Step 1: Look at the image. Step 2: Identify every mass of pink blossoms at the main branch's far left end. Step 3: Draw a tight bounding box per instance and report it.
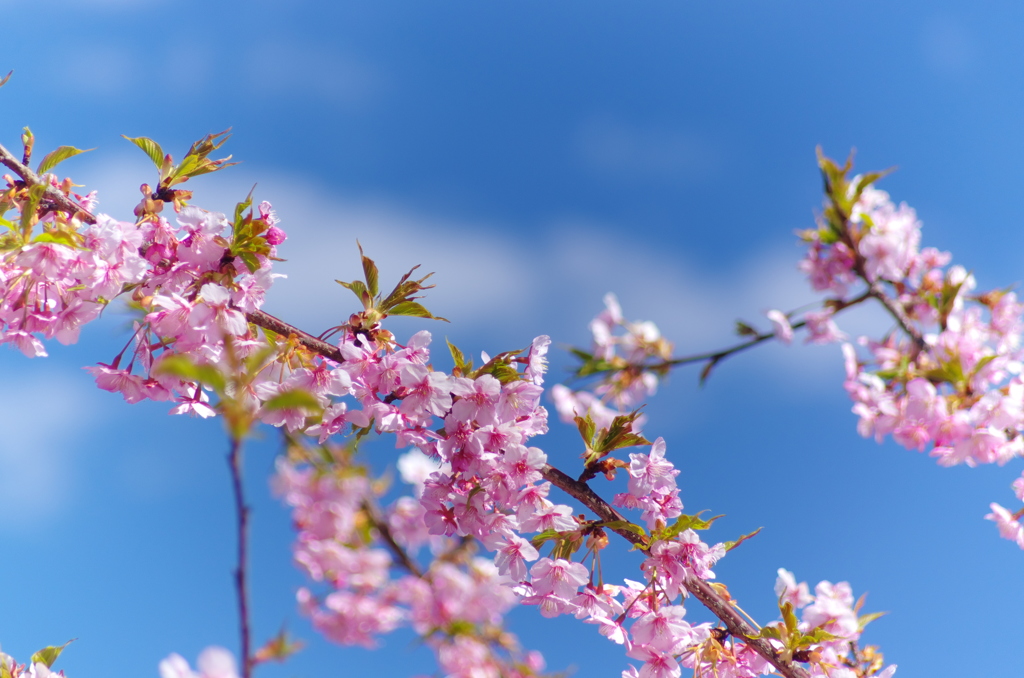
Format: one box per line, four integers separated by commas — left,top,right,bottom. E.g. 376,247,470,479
0,168,285,417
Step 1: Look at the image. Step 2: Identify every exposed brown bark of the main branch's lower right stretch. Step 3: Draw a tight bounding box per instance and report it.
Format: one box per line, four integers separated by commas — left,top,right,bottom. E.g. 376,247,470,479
542,465,810,678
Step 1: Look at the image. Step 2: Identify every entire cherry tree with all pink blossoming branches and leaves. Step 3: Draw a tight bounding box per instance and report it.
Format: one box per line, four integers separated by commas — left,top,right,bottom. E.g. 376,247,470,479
0,73,1024,678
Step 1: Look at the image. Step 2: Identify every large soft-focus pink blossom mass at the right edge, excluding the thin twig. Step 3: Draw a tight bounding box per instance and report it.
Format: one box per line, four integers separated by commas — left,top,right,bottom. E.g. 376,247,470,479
790,159,1024,548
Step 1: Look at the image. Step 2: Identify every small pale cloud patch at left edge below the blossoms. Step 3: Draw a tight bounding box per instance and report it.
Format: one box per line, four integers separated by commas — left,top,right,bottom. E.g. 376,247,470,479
0,372,92,525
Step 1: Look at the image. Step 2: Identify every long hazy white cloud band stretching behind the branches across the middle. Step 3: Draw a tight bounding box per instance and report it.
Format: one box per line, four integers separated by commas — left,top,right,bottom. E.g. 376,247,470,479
72,154,890,387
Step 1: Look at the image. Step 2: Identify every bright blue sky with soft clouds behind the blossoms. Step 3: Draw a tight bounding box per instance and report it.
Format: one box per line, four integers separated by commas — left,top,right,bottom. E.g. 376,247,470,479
0,0,1024,678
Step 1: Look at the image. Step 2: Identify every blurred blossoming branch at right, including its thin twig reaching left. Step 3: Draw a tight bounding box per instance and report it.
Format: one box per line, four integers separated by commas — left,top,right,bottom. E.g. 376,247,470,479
553,150,1024,549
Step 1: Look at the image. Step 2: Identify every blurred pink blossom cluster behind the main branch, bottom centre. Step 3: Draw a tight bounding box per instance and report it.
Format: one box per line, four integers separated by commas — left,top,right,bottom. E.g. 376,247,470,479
273,448,543,678
